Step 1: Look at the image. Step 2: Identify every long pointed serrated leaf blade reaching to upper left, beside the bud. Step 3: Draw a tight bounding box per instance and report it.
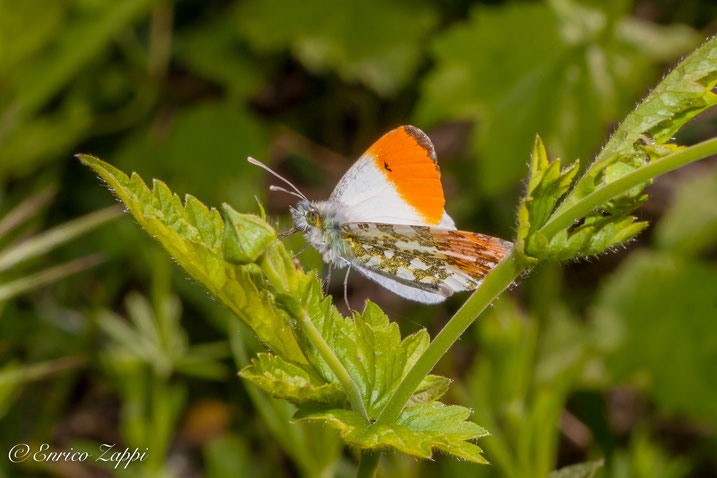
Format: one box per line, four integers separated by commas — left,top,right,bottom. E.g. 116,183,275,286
79,155,307,365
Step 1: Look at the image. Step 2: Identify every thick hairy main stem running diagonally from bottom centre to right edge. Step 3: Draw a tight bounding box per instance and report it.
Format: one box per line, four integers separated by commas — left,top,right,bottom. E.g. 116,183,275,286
356,134,717,478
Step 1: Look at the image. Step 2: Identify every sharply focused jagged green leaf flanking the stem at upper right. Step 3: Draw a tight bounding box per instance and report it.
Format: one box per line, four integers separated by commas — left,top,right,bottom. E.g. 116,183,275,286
517,38,717,260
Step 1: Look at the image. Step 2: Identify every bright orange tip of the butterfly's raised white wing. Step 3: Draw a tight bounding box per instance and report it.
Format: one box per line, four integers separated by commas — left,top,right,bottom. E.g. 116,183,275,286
366,125,445,225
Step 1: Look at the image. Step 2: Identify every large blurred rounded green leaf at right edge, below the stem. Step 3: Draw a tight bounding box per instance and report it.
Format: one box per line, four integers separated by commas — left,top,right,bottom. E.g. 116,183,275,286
593,252,717,423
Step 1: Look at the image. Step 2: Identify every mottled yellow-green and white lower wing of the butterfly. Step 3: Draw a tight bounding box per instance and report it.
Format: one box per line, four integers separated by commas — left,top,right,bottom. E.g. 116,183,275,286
341,222,512,298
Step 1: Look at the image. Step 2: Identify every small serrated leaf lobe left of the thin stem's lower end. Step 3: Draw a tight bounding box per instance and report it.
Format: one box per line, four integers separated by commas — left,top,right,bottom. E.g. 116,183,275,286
239,353,346,407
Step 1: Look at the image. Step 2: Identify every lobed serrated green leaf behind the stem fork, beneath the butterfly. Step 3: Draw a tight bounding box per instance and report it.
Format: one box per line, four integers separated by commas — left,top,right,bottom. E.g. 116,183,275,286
241,286,451,417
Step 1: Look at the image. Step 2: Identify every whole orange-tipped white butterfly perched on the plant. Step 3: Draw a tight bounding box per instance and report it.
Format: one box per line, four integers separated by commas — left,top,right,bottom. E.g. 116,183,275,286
249,126,513,304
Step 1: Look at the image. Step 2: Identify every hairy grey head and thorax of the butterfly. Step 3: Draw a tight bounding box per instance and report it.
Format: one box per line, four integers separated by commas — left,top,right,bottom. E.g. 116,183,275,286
291,201,351,267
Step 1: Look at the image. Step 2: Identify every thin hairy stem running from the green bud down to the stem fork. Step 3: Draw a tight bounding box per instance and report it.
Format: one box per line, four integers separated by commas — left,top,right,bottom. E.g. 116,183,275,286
259,254,369,421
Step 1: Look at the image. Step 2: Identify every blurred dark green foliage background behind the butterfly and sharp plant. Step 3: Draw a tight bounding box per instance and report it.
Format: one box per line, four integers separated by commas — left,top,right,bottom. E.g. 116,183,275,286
0,0,717,478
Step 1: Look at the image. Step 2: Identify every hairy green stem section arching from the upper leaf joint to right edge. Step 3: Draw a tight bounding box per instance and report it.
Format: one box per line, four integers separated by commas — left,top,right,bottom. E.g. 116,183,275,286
540,138,717,237
